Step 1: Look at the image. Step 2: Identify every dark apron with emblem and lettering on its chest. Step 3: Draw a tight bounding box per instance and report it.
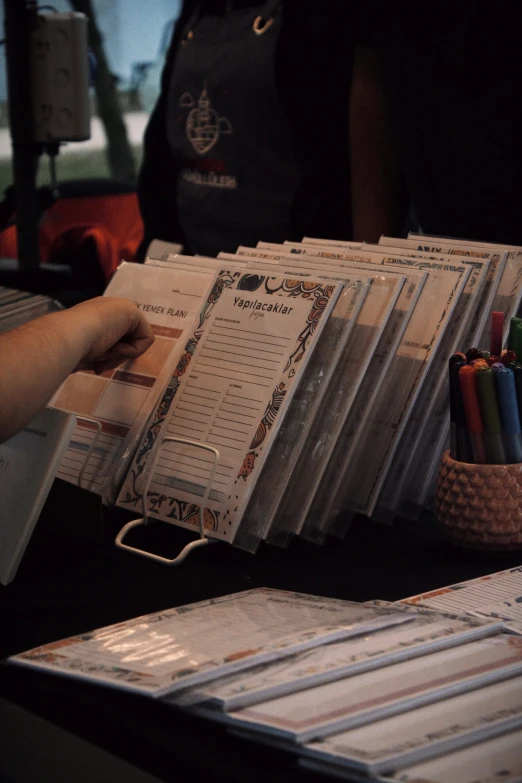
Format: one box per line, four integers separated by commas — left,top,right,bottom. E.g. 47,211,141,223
167,0,301,256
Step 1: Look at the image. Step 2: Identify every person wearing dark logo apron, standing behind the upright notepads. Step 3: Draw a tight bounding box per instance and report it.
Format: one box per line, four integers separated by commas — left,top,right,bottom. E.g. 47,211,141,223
138,0,362,256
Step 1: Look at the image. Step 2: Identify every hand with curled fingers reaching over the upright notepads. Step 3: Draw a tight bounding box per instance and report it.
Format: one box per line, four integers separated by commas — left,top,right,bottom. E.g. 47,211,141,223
72,296,154,374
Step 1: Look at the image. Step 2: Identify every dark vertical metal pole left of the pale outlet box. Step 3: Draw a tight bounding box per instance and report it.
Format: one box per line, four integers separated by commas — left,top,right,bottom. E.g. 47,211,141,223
4,0,40,269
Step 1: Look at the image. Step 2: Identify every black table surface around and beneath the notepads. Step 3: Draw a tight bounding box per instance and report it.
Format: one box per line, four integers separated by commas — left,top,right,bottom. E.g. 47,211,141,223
0,481,522,781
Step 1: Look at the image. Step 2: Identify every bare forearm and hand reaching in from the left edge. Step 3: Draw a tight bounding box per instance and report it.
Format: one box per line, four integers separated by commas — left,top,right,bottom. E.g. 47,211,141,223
0,297,154,442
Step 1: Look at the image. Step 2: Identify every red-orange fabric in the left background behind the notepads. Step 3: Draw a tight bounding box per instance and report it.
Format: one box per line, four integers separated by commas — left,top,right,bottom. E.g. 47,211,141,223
0,193,143,280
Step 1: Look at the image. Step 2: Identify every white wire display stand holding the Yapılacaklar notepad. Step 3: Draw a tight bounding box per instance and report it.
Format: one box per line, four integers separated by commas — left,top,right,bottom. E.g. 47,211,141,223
114,435,219,566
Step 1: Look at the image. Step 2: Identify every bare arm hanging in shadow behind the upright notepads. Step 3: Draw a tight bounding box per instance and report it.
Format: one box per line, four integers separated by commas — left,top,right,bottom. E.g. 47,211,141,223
350,47,408,242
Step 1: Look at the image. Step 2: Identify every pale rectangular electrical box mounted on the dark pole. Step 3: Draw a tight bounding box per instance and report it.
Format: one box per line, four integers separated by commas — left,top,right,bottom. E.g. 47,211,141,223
31,13,91,144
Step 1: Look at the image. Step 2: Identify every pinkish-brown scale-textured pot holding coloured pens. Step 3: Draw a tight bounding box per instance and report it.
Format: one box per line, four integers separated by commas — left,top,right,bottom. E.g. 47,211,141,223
435,451,522,552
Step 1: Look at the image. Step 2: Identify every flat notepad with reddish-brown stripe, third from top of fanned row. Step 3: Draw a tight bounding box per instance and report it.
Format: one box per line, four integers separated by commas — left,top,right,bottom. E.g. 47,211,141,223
200,634,522,744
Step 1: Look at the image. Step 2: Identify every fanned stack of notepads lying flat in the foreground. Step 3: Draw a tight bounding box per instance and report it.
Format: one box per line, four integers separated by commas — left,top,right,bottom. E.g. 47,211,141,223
9,580,522,783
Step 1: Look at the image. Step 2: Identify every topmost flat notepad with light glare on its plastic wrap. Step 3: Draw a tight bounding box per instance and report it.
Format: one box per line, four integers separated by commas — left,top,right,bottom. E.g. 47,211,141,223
9,588,408,696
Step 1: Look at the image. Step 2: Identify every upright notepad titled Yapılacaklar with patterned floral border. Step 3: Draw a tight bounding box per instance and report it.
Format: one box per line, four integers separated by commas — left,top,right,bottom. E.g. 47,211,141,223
118,270,343,541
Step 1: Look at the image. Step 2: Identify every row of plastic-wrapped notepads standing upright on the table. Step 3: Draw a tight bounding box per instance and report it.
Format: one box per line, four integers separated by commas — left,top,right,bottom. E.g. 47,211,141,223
39,230,522,551
